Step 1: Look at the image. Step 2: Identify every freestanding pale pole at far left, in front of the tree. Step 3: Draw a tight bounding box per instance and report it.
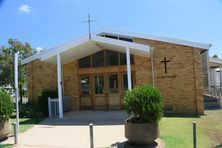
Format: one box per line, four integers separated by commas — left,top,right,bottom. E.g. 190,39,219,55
14,52,19,134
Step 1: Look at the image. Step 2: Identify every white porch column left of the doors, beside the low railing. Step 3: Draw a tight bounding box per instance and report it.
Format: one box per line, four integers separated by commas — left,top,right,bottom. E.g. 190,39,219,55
57,53,63,118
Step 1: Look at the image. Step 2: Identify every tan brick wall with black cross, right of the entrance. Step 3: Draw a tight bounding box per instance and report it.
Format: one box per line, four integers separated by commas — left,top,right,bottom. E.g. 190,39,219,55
134,38,204,114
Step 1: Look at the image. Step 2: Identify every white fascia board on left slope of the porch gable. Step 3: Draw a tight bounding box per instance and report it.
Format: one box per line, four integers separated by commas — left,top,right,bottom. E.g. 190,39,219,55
41,36,89,61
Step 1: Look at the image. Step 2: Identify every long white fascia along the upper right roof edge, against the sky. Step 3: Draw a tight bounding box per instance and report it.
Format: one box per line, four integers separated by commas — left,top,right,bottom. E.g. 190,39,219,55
94,29,212,49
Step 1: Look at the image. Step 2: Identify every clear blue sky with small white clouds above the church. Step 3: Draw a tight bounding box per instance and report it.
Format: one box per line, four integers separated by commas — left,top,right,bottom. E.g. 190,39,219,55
0,0,222,58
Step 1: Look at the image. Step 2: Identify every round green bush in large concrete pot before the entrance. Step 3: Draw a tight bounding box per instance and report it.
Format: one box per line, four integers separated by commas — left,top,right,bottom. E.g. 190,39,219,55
124,85,163,145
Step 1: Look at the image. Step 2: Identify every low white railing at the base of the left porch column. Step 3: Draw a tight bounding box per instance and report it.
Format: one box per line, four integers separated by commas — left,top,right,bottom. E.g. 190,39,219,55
48,97,70,118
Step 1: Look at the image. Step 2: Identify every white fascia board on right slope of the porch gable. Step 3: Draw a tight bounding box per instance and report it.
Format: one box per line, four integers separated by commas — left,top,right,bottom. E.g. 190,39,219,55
92,35,150,52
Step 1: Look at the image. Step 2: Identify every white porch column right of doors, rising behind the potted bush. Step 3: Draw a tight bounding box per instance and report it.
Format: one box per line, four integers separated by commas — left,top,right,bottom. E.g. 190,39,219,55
126,47,132,91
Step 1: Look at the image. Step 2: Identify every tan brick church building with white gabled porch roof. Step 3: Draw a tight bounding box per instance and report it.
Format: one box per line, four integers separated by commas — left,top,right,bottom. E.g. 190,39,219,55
22,29,211,117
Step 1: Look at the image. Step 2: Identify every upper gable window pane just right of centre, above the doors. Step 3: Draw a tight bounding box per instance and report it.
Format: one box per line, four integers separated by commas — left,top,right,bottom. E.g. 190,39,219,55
106,51,119,66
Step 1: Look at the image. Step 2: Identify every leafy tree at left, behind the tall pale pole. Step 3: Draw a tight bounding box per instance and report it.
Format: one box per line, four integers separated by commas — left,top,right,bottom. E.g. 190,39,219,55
0,39,36,103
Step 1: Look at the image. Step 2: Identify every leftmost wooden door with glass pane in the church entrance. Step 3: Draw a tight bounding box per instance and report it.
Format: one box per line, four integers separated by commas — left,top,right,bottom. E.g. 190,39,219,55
80,75,93,109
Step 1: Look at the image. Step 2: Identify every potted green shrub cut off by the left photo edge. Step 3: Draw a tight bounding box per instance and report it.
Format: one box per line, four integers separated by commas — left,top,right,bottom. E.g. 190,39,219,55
0,89,13,139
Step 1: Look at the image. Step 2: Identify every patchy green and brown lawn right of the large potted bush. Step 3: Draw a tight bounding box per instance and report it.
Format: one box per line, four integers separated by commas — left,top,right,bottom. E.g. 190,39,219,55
160,110,222,148
